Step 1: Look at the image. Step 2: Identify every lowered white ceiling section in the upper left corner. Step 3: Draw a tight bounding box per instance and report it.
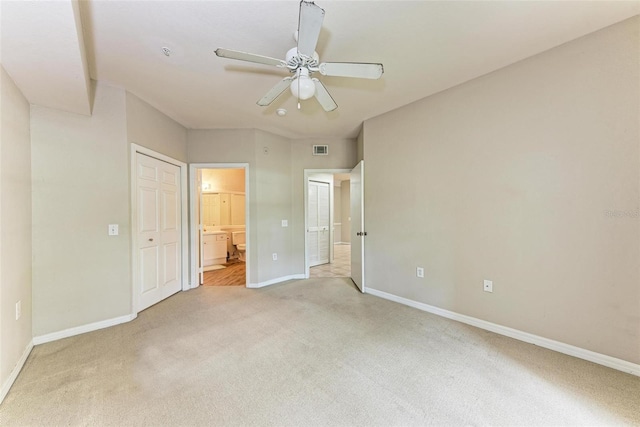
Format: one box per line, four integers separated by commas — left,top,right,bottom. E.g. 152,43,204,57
0,0,91,114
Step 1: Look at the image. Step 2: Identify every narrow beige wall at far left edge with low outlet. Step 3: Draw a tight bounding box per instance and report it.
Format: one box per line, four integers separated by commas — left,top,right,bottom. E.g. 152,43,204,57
0,65,32,390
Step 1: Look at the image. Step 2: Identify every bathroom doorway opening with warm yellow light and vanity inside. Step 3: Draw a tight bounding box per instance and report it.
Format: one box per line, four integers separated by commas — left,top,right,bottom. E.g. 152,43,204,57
189,163,250,288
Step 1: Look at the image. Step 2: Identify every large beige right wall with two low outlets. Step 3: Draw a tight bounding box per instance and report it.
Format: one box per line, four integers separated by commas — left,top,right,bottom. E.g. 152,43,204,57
364,18,640,363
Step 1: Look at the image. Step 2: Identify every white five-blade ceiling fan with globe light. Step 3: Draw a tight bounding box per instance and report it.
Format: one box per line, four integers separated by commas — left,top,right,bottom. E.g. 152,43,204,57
215,0,384,111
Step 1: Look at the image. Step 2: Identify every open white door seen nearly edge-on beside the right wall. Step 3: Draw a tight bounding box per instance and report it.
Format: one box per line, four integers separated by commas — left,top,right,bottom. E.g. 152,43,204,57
351,160,367,292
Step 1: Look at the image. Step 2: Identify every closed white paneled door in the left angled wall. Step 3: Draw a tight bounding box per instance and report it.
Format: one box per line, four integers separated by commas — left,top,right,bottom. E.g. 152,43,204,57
135,153,182,311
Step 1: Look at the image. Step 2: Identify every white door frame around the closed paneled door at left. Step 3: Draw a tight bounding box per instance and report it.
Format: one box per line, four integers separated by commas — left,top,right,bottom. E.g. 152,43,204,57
129,143,190,315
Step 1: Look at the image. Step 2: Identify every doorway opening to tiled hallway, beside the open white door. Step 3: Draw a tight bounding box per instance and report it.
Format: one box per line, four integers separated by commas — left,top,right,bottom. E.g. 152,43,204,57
305,169,351,278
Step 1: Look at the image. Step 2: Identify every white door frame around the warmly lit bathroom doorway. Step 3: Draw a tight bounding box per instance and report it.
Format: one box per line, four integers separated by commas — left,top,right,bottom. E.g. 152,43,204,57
188,163,251,289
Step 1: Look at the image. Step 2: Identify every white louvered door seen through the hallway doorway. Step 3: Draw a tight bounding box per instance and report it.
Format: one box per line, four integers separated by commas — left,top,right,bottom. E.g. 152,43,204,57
307,181,330,267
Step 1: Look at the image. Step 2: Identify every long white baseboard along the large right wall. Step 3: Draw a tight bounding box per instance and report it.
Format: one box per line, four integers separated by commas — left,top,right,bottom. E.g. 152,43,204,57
366,288,640,376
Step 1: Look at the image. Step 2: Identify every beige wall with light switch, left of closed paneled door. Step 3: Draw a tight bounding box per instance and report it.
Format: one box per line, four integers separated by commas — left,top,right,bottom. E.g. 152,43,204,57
31,85,131,336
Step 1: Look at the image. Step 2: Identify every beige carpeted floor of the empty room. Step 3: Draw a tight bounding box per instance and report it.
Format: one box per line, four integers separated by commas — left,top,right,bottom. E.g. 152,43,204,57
0,278,640,426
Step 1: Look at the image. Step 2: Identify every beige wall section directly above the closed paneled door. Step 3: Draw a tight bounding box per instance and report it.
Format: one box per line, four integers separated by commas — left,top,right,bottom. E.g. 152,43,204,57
126,92,187,162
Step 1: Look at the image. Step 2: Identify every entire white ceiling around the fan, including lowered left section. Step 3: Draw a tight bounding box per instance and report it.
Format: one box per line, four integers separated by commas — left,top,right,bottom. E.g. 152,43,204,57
1,0,640,138
